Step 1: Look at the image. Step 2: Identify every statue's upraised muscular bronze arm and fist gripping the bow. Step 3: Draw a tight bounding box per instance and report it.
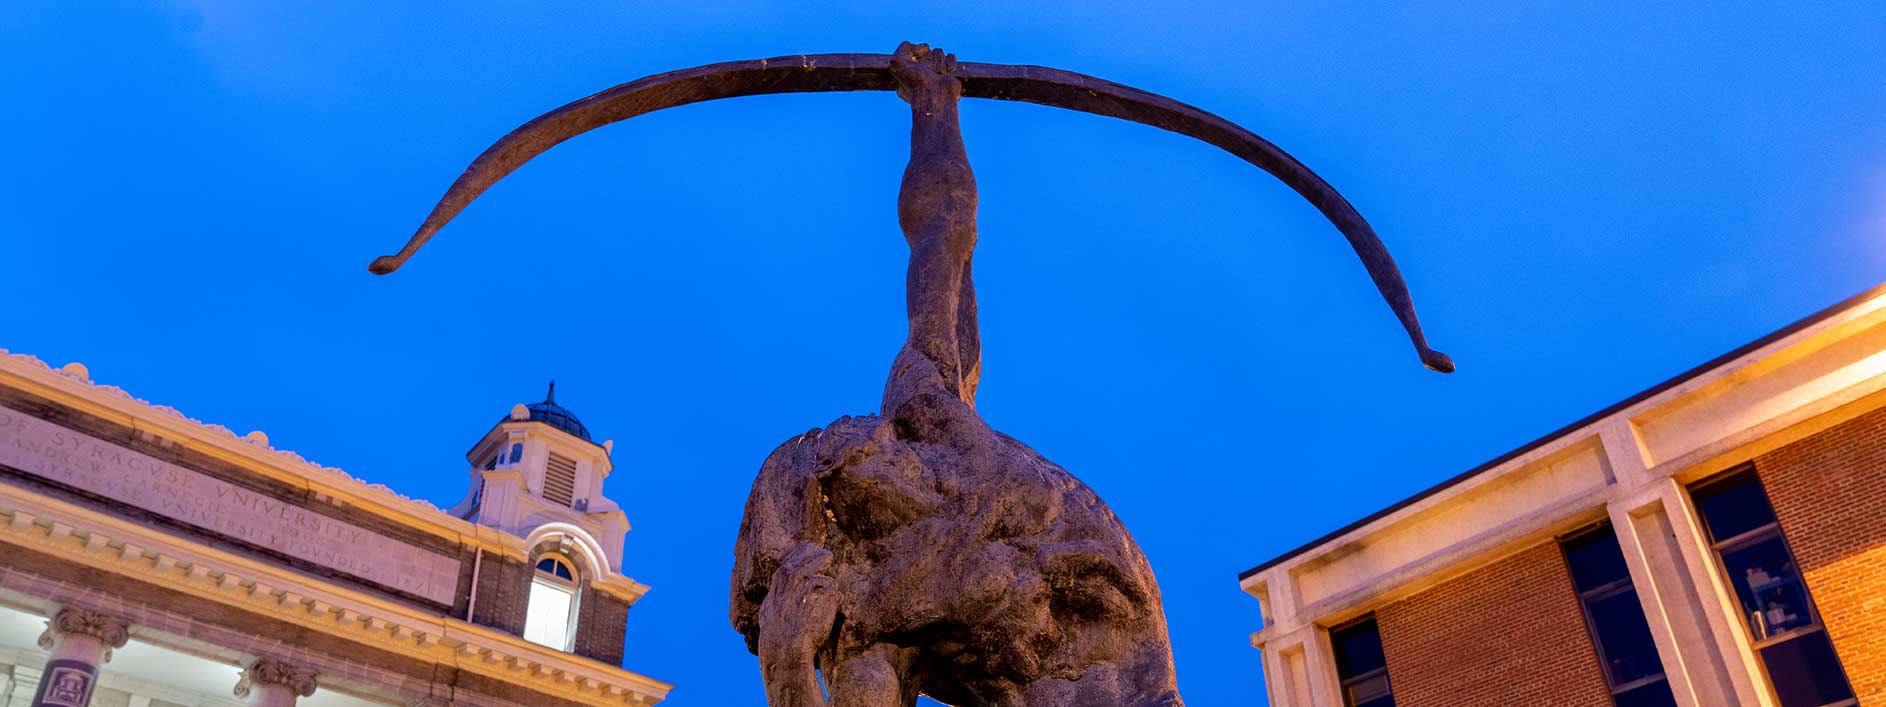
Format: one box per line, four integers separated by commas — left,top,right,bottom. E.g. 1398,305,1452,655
885,43,981,413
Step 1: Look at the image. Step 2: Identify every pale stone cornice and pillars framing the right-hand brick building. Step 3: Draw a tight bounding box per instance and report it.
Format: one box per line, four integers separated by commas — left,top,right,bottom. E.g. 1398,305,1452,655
1239,285,1886,707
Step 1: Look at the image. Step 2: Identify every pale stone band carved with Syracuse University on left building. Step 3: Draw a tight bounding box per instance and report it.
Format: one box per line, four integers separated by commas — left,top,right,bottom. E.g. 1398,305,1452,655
0,407,458,603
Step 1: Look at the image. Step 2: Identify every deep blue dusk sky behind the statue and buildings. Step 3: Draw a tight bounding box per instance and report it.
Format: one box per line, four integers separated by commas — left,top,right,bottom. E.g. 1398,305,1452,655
0,0,1886,707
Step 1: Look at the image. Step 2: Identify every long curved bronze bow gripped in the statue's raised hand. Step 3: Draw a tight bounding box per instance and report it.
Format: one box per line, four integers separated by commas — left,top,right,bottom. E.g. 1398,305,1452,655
368,55,1454,373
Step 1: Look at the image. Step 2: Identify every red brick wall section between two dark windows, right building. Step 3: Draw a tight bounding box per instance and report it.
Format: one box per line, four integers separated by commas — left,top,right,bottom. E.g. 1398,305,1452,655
1375,543,1611,707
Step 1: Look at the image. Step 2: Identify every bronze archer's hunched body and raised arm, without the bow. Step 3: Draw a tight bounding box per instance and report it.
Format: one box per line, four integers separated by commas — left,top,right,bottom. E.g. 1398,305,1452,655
730,45,1181,707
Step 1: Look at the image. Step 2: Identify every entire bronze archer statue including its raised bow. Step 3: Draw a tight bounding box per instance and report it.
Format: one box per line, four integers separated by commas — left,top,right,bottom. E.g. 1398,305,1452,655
370,43,1454,707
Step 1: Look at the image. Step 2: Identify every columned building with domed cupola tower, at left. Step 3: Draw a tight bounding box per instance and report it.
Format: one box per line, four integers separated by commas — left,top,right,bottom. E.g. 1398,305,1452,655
0,351,671,707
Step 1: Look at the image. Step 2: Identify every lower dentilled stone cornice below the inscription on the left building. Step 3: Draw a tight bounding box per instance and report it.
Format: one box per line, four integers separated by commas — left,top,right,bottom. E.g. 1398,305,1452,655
0,485,673,705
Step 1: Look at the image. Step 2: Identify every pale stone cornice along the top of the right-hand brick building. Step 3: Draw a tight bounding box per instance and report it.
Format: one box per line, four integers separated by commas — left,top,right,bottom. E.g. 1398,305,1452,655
1239,285,1886,645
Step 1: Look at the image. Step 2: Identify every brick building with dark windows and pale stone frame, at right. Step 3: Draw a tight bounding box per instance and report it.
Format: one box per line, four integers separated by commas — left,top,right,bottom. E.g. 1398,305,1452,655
1239,287,1886,707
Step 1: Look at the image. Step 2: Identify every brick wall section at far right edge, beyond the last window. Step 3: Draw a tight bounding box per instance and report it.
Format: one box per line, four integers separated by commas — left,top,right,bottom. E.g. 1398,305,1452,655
1756,409,1886,705
